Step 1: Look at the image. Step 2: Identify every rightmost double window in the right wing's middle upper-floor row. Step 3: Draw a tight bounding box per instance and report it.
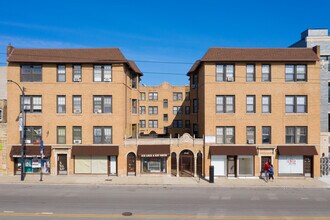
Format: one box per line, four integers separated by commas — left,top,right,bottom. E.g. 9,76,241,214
285,96,307,113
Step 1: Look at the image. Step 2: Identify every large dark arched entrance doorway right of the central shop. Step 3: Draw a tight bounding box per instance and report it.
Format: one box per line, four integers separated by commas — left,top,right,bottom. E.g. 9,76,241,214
179,150,194,177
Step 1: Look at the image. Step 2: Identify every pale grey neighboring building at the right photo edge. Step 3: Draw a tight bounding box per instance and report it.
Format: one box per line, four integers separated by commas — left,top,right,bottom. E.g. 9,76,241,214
290,28,330,157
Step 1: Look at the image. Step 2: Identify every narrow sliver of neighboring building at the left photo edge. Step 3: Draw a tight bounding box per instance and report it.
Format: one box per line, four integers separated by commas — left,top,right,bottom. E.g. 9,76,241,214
0,66,7,175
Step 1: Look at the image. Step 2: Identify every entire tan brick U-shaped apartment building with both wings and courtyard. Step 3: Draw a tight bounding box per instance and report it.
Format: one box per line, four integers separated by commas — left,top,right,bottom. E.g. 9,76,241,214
7,46,320,178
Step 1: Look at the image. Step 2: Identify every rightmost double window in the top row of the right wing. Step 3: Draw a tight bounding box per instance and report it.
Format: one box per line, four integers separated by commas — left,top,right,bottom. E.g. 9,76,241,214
285,64,307,82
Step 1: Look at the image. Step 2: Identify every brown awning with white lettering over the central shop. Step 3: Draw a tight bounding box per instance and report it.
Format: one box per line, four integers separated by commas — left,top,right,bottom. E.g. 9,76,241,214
137,145,170,157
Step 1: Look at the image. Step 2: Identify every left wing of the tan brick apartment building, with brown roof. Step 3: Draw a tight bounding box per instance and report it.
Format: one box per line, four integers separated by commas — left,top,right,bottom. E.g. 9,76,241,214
7,46,142,175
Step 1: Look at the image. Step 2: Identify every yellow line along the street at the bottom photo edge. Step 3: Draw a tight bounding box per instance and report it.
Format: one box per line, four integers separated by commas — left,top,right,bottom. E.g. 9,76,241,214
0,212,330,220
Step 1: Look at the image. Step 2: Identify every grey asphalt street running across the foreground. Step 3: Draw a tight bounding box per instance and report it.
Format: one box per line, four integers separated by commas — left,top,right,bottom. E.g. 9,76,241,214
0,184,330,219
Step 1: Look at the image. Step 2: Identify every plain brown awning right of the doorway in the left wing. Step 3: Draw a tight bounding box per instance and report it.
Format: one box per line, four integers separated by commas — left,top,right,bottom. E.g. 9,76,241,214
72,146,119,156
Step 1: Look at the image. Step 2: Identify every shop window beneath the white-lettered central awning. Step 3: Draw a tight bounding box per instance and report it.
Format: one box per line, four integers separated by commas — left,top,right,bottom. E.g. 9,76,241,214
142,157,167,173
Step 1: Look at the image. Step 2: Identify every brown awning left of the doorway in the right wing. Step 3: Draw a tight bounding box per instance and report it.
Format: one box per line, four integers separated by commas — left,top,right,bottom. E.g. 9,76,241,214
210,146,257,156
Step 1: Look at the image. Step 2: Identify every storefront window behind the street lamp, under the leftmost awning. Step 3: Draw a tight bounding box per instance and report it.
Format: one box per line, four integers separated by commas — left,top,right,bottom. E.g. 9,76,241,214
15,157,50,174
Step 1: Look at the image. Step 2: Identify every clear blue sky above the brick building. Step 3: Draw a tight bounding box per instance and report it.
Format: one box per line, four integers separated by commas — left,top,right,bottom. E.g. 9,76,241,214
0,0,330,85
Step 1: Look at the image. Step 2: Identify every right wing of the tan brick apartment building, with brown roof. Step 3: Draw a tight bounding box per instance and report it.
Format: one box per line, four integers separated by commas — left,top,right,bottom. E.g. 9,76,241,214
187,47,320,177
